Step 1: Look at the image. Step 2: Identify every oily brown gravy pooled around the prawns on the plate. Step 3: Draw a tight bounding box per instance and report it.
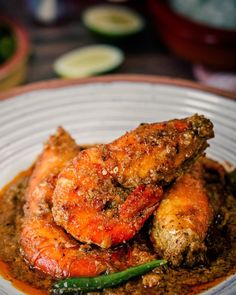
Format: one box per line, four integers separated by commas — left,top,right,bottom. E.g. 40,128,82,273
0,168,236,295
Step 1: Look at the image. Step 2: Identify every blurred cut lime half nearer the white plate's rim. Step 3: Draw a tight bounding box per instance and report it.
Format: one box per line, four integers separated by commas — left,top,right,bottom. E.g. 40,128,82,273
53,45,124,78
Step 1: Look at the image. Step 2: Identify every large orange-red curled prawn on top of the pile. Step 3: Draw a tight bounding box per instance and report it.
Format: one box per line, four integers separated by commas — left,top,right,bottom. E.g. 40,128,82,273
52,115,214,248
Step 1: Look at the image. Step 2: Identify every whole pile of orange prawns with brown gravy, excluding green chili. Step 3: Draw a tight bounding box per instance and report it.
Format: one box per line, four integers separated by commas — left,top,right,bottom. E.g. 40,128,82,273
0,115,236,295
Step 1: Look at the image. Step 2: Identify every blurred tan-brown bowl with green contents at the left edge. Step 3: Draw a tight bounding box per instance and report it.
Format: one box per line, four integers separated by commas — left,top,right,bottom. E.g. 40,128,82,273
0,15,29,91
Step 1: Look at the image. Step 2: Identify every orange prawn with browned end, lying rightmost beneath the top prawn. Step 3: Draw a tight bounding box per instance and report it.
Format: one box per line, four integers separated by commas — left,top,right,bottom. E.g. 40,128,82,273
151,157,225,267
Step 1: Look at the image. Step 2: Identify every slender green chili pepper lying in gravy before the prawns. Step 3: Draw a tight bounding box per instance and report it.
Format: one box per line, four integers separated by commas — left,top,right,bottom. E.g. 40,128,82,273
52,260,167,294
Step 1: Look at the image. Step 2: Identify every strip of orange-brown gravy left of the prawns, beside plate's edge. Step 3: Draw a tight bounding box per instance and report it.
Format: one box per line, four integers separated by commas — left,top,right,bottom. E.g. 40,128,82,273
0,168,50,295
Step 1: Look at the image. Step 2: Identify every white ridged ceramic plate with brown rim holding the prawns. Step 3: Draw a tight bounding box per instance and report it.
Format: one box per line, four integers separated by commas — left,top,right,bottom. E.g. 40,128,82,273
0,75,236,295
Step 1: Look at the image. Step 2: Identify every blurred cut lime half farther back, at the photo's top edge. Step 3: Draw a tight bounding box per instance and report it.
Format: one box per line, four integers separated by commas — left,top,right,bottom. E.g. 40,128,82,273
82,5,145,37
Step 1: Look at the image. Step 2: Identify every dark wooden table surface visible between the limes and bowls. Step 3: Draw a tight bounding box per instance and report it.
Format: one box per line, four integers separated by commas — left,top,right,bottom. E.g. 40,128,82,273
0,0,194,83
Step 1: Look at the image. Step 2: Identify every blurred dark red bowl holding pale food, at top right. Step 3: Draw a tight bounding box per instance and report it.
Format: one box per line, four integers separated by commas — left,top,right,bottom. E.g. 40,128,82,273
148,0,236,69
